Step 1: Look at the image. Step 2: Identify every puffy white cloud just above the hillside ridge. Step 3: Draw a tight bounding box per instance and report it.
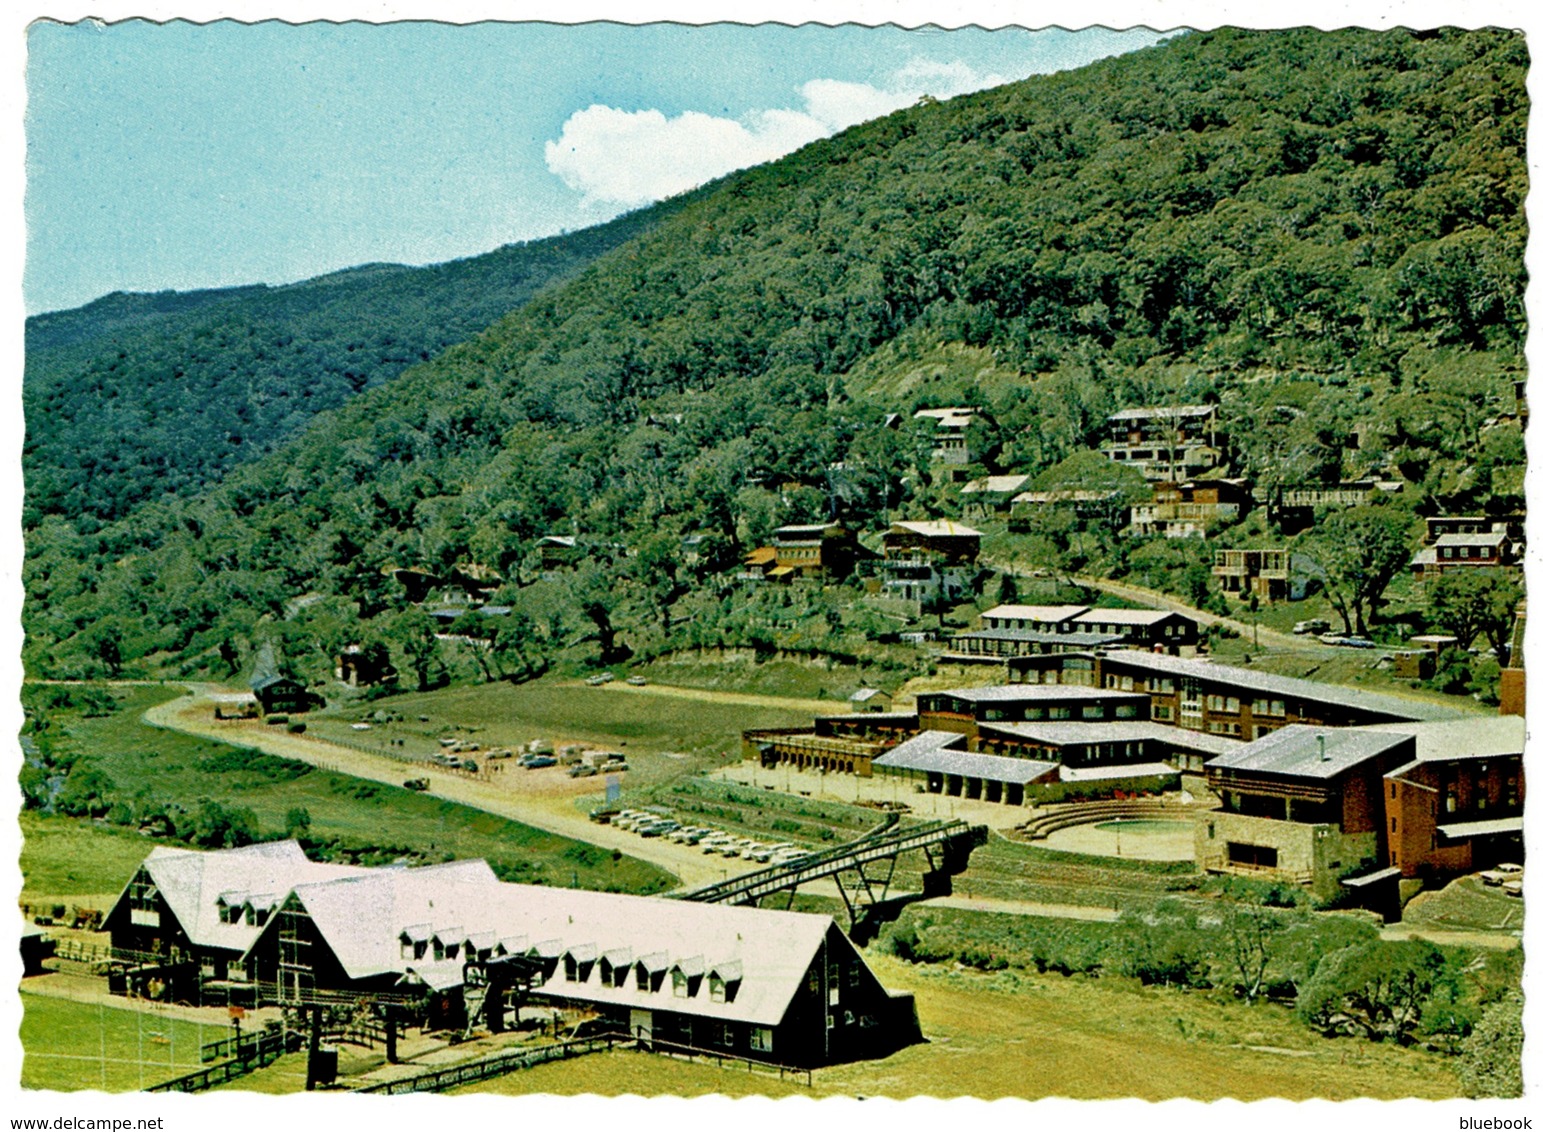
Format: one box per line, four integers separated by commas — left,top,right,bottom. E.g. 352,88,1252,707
546,59,1011,208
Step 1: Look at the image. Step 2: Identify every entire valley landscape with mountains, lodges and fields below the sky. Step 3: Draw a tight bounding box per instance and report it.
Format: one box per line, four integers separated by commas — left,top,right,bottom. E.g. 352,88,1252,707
20,28,1529,1100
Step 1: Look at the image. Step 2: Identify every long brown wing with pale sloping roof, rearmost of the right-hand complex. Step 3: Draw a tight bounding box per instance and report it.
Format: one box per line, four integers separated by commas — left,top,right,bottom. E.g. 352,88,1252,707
1008,649,1458,740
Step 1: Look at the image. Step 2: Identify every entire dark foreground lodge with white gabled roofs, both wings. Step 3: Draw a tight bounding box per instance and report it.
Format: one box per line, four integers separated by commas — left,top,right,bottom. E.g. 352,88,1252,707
106,841,920,1066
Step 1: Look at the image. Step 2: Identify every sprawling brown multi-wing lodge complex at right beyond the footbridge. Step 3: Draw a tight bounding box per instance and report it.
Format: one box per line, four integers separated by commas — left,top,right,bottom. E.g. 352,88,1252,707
745,649,1524,896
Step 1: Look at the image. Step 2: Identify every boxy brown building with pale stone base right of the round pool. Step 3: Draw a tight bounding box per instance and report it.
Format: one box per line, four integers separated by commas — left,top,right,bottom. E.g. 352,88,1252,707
1196,725,1415,898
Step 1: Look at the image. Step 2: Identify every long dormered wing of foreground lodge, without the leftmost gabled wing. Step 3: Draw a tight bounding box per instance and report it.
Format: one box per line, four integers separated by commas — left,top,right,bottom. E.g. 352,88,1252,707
245,862,921,1066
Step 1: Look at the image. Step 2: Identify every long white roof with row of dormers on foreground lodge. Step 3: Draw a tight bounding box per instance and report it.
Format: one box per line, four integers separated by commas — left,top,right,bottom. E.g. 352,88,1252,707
249,861,833,1026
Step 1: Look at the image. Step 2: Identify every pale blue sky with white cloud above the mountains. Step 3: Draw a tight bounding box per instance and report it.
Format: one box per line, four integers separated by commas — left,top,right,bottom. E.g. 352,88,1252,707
25,22,1156,313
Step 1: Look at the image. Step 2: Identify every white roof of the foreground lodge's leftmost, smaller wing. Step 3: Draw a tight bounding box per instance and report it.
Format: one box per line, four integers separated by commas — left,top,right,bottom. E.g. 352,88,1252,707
119,841,370,952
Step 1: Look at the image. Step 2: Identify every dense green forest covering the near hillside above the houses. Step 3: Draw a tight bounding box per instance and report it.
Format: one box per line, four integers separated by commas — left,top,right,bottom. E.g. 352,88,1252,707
25,29,1528,683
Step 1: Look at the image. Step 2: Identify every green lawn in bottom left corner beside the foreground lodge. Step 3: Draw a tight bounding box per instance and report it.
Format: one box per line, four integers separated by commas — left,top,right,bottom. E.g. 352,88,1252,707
22,992,220,1092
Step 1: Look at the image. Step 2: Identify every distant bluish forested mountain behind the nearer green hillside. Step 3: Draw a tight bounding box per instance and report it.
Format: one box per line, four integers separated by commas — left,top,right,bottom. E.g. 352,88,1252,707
23,205,688,531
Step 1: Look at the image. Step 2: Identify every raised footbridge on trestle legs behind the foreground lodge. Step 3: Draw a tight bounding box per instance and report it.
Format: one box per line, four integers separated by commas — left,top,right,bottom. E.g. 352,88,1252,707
676,820,989,942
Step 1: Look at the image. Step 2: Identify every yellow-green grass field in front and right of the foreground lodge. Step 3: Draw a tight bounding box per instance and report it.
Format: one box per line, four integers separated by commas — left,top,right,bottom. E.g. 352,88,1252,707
453,956,1460,1100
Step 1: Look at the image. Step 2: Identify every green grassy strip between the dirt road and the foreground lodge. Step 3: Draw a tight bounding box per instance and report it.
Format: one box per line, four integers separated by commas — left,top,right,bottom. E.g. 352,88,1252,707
28,688,671,891
